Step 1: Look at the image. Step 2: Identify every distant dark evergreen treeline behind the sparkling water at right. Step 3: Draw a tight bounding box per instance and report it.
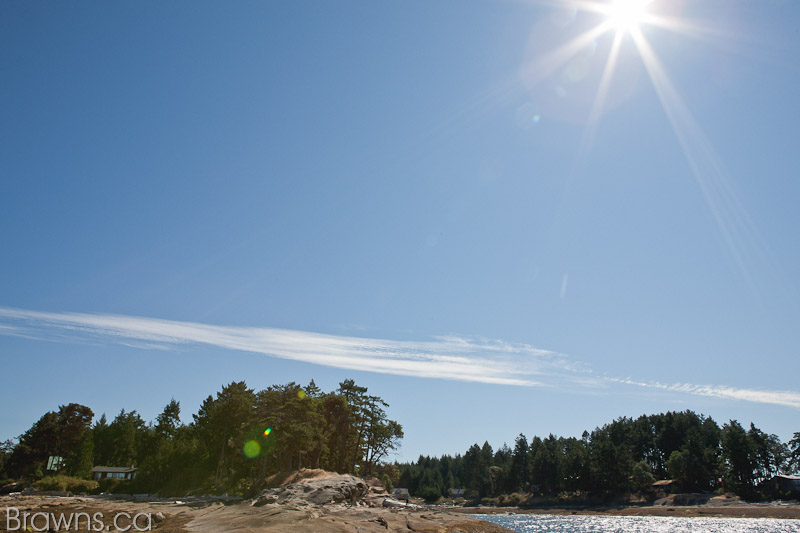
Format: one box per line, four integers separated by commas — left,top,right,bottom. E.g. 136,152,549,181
397,411,800,503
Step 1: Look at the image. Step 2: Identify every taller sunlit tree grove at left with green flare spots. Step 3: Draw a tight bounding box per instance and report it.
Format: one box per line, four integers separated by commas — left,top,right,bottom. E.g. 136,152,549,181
0,380,403,494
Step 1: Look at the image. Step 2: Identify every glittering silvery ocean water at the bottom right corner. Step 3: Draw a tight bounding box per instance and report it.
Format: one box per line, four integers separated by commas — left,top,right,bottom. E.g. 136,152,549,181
471,514,800,533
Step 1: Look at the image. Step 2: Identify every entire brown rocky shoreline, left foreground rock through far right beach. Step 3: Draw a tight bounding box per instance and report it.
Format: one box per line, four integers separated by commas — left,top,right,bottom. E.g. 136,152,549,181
0,470,800,533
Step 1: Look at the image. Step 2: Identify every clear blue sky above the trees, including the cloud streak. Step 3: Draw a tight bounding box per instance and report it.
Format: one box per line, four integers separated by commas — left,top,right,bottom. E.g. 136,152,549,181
0,0,800,459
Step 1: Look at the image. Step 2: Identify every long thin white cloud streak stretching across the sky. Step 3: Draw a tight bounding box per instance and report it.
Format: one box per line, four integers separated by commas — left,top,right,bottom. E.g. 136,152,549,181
0,307,800,409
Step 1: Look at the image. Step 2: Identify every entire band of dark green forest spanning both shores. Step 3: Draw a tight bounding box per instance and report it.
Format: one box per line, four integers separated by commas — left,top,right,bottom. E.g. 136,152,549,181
0,380,800,504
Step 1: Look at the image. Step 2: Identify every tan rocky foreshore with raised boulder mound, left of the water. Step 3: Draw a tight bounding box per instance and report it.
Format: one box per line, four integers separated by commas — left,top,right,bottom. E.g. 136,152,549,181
0,471,509,533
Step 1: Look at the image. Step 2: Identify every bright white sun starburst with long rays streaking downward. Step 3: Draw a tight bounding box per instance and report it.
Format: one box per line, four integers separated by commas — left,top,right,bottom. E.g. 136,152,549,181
521,0,764,290
